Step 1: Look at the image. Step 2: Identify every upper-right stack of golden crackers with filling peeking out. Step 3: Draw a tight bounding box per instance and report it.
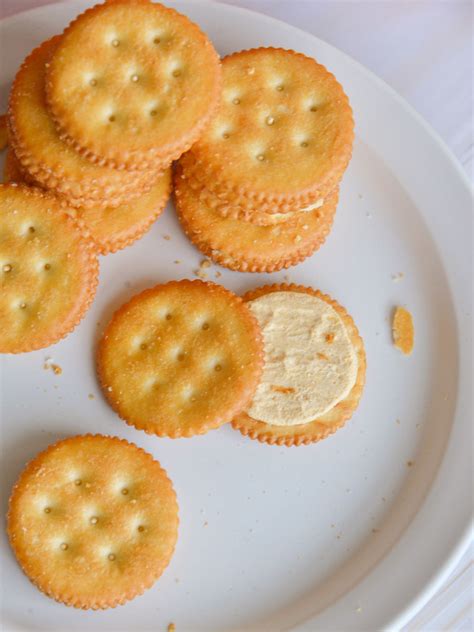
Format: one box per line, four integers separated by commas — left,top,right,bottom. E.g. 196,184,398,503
175,48,354,272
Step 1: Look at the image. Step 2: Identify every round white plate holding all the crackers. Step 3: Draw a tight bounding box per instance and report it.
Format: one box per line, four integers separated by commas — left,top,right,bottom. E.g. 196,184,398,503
0,0,472,631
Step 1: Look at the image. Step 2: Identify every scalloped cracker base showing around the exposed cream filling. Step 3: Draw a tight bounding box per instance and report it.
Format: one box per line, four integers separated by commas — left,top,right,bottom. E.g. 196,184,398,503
232,284,366,447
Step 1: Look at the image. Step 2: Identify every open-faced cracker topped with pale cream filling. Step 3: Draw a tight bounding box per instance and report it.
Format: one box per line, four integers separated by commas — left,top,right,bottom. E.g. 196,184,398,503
232,284,366,446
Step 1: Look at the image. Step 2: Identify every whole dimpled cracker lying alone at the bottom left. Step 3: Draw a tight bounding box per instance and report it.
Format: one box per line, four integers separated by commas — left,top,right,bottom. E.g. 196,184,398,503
8,435,178,609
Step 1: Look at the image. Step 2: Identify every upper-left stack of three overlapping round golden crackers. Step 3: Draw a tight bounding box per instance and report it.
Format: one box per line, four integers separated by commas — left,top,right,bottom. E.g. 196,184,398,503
6,0,220,254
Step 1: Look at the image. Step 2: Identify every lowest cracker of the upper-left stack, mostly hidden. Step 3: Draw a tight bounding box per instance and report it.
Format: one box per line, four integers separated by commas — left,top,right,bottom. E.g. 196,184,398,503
4,149,171,255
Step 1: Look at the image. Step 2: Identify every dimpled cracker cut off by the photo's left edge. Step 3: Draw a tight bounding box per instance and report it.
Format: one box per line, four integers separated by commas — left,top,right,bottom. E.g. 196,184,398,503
0,185,98,353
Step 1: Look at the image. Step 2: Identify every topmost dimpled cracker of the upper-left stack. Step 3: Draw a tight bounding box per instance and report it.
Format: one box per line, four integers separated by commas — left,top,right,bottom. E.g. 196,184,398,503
46,0,220,167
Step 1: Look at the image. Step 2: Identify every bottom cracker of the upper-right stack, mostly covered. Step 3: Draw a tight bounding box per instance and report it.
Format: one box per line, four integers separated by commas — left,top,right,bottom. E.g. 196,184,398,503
175,173,338,272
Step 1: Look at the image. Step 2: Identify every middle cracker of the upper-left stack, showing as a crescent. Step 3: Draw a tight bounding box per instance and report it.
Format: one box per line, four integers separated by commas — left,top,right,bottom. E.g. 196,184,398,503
9,36,159,206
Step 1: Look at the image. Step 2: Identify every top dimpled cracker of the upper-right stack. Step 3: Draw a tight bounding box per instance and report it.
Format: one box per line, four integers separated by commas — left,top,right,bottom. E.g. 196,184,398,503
187,48,354,202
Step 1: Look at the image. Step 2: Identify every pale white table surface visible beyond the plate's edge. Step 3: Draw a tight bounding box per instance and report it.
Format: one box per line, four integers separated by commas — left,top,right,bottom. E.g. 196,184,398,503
0,0,474,632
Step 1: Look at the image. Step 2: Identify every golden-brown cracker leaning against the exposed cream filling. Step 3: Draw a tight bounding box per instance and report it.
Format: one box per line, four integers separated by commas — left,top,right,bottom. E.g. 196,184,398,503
97,280,262,438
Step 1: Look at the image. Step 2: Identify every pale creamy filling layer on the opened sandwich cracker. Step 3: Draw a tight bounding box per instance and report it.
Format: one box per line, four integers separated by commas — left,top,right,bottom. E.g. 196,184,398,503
247,291,357,426
